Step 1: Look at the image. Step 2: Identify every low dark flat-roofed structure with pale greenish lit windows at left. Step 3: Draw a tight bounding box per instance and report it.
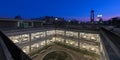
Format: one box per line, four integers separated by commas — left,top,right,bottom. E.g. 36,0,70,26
0,18,42,29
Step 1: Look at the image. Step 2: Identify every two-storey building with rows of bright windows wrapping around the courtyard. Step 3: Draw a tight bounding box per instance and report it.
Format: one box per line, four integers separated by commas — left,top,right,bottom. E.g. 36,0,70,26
1,20,119,60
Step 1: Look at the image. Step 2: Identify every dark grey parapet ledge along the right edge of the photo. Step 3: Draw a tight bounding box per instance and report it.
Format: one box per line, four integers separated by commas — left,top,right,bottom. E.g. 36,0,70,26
101,28,120,60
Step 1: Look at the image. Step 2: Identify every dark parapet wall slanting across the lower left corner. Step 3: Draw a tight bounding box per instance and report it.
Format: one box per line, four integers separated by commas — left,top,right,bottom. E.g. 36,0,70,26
0,31,31,60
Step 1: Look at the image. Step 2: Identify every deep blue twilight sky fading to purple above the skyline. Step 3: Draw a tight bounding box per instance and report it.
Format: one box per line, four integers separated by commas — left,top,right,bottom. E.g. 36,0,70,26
0,0,120,20
